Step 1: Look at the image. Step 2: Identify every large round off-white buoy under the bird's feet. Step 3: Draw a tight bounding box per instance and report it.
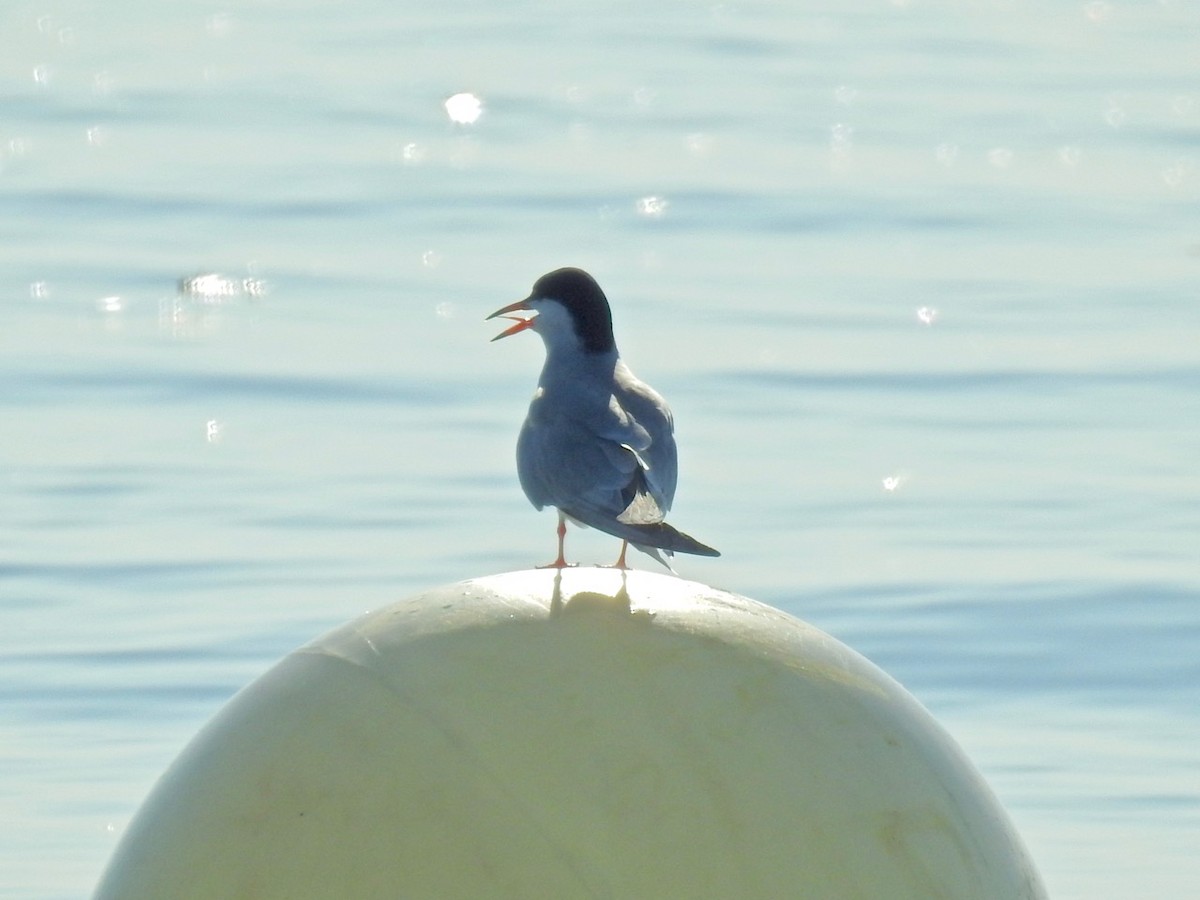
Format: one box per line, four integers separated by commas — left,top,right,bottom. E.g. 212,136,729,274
96,569,1045,900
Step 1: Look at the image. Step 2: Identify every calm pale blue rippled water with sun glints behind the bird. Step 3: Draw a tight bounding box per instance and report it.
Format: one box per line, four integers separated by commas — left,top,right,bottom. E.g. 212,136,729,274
0,0,1200,899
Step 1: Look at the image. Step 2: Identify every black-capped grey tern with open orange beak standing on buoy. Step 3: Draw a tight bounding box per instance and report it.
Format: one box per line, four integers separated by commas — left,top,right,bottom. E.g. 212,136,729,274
487,266,720,572
